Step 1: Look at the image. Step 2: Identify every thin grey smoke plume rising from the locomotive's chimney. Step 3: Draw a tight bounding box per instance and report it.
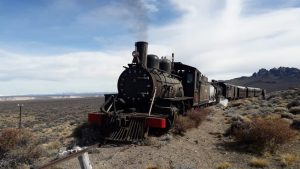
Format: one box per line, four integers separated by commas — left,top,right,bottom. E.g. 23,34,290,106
121,0,154,41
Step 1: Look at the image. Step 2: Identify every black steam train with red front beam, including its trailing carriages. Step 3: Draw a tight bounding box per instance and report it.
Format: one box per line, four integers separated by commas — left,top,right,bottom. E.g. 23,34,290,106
88,42,265,142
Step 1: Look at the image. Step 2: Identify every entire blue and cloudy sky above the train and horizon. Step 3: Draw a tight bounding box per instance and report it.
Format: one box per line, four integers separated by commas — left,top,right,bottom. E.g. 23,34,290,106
0,0,300,96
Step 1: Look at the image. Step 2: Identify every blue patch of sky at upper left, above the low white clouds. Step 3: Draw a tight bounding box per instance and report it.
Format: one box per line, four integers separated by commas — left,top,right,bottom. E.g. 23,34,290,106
0,0,179,53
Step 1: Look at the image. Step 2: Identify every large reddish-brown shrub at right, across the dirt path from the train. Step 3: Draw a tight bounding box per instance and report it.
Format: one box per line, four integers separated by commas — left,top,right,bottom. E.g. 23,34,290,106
233,118,295,151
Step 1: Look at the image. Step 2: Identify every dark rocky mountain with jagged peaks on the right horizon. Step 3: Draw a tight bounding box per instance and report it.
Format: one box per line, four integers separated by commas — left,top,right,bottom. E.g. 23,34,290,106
226,67,300,92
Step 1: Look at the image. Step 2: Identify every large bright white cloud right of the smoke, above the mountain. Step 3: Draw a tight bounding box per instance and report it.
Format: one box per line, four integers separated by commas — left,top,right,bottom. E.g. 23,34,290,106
150,0,300,79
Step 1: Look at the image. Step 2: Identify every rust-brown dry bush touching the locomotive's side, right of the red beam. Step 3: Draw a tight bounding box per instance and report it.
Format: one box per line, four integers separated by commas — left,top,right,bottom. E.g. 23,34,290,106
173,109,209,135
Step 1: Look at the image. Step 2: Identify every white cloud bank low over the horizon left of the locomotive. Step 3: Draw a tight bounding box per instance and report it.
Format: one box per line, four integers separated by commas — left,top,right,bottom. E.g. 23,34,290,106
0,50,131,95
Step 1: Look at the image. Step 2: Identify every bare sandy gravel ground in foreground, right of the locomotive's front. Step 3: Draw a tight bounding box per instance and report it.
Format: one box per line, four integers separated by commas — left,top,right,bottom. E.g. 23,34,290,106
59,108,300,169
